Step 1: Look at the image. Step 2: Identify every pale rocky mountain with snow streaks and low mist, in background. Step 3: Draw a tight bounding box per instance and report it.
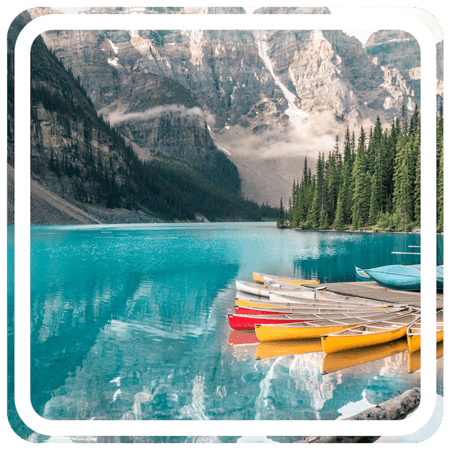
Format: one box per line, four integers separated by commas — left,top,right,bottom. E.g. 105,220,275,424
8,6,442,214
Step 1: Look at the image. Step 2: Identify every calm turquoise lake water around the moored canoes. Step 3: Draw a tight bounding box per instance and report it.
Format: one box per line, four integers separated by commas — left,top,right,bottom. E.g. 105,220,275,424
7,223,443,442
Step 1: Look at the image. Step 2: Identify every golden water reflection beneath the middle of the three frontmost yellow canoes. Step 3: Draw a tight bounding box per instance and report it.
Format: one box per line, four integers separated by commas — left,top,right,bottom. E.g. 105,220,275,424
321,340,408,375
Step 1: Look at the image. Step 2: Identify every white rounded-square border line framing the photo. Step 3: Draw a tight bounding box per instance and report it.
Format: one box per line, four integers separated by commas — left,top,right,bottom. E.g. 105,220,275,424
14,9,436,436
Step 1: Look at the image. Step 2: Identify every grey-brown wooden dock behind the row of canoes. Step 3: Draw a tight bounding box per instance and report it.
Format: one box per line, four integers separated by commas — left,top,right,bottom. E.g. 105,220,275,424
314,281,444,309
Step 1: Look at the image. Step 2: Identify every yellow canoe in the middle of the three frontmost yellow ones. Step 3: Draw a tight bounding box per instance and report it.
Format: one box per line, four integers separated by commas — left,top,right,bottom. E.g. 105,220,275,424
320,310,420,354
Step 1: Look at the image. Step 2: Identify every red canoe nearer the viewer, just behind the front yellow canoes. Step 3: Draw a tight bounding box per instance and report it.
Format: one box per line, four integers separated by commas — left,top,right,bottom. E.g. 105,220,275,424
228,308,408,330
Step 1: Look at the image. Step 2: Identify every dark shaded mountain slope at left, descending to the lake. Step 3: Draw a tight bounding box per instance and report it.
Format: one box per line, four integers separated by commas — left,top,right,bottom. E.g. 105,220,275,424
7,12,270,229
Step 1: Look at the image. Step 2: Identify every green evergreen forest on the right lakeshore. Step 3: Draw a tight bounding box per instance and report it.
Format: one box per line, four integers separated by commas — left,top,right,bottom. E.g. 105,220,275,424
277,104,444,232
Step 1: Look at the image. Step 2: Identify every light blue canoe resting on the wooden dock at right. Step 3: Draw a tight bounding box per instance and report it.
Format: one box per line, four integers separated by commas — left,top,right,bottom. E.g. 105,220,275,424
355,264,444,291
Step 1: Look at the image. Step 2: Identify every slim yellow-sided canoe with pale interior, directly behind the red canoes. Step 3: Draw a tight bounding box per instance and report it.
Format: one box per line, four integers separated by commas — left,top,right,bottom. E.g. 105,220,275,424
235,298,405,310
